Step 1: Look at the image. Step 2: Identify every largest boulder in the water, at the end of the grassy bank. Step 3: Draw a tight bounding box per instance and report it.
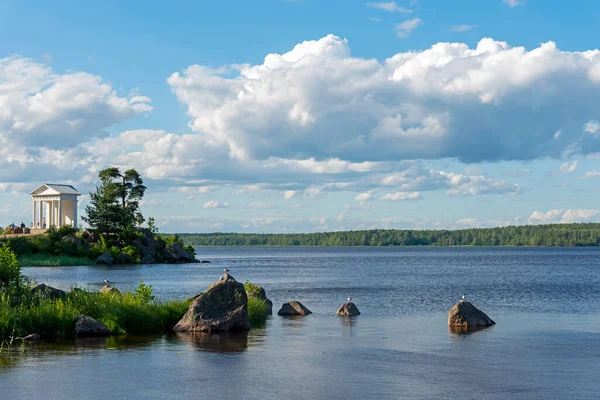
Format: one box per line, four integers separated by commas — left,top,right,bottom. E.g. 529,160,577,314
173,274,250,332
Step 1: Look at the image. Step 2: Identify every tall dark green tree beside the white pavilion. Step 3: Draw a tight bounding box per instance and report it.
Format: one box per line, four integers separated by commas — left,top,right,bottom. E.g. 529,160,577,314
83,167,146,235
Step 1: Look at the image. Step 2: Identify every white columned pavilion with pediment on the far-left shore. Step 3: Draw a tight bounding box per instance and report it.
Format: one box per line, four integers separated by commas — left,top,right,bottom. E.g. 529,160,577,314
29,183,81,229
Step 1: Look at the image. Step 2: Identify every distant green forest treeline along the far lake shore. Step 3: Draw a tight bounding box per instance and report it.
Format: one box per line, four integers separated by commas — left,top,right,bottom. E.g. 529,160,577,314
179,223,600,246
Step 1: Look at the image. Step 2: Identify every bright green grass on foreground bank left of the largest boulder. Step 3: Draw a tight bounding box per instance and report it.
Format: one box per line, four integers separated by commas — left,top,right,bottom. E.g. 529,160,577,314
0,291,190,341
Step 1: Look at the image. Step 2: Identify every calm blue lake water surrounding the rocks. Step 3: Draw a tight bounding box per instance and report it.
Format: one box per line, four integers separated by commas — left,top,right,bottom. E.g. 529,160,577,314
0,248,600,400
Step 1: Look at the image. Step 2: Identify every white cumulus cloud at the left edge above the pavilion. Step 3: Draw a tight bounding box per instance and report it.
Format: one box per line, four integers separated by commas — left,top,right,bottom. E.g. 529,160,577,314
0,56,152,153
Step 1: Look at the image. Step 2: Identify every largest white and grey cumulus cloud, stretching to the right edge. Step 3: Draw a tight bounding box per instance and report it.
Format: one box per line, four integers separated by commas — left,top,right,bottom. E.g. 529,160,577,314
168,35,600,164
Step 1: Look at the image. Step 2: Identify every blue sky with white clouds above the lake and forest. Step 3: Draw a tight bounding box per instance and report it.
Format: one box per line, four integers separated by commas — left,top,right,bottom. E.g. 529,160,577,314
0,0,600,233
